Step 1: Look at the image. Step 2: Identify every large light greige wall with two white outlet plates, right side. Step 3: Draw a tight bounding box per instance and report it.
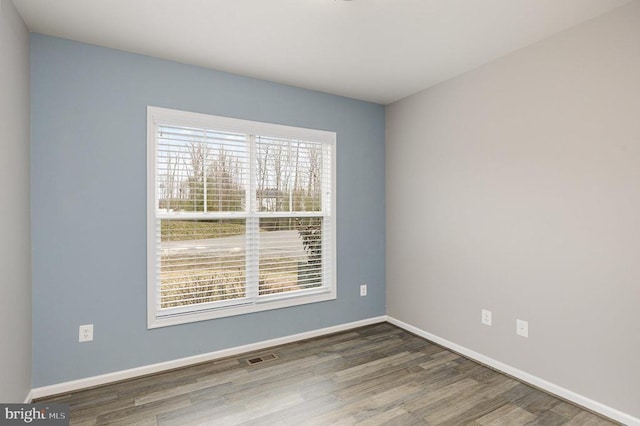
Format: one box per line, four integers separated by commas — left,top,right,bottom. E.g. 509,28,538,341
386,1,640,417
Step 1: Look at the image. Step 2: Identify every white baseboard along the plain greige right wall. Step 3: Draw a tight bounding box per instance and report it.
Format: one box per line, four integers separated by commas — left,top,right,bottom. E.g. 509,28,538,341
387,316,640,426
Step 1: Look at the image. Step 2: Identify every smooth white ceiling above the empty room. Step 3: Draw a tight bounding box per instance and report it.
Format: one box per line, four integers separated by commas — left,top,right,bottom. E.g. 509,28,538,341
13,0,631,104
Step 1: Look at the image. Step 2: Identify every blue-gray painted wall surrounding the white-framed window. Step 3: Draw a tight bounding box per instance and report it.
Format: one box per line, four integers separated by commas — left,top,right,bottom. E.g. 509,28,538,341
31,34,385,387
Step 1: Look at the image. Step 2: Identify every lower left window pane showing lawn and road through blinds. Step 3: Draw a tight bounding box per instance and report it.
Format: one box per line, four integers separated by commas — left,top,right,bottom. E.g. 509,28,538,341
160,219,246,308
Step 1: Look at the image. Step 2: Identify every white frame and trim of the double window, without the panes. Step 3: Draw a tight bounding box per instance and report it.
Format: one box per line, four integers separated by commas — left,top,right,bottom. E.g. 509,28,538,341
147,106,337,329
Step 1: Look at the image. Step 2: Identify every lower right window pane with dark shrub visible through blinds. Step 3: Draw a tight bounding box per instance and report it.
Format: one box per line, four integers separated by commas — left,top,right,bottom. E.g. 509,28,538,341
258,217,322,296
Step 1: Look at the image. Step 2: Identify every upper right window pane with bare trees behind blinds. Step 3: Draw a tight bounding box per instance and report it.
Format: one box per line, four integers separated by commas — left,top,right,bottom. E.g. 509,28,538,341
256,136,324,212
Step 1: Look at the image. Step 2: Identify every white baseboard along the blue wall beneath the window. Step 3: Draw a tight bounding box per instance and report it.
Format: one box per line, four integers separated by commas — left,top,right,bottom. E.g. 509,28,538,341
28,315,387,399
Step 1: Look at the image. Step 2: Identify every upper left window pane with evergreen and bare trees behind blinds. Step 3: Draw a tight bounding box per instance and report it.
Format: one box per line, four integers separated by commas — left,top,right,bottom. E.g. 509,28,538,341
156,126,249,212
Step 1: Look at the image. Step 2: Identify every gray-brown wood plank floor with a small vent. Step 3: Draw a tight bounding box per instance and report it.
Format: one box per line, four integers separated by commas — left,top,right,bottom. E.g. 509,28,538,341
39,323,615,426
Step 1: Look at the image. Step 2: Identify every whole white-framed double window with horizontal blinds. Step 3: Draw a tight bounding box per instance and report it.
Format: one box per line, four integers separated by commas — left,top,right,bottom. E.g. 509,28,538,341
147,107,336,328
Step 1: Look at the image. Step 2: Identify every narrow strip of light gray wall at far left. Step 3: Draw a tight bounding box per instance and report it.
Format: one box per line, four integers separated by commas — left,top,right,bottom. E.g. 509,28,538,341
0,0,31,402
